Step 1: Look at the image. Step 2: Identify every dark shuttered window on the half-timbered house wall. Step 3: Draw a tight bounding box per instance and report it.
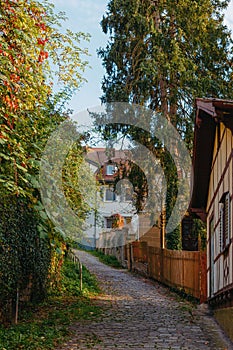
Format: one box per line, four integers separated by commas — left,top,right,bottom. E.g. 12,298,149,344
219,192,231,251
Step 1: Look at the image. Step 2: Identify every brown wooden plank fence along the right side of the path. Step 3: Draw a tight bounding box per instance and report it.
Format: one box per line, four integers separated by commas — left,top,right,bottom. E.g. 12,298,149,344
103,241,207,303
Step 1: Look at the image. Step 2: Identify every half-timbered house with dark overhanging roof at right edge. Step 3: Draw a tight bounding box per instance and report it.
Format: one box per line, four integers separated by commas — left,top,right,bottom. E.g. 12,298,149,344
191,99,233,309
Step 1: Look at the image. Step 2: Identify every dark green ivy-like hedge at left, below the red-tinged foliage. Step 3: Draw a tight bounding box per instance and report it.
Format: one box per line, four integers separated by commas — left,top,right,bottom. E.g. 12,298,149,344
0,196,51,322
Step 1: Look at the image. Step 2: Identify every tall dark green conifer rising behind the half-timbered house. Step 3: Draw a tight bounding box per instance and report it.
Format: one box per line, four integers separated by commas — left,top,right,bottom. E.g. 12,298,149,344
96,0,233,249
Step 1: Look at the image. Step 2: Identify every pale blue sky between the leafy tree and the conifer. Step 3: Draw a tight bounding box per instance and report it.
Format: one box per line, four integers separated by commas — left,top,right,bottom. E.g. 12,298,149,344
50,0,233,114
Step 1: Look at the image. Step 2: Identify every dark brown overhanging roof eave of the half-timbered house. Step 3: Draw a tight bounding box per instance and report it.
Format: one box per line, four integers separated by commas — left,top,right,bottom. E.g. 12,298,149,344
190,99,233,216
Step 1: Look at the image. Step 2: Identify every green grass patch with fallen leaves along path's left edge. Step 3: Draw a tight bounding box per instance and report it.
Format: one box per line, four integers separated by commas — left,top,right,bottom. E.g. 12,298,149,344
0,260,101,350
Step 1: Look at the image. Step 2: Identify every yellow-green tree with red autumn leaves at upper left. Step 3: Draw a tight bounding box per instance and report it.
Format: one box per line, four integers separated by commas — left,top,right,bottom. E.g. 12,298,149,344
0,0,87,195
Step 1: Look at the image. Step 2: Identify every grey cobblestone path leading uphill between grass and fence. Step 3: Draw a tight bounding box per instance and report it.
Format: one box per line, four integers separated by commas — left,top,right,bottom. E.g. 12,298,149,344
60,252,233,350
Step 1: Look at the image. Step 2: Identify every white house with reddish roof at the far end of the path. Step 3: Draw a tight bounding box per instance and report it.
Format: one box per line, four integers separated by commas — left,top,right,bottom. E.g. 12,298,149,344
81,148,137,248
